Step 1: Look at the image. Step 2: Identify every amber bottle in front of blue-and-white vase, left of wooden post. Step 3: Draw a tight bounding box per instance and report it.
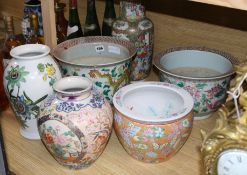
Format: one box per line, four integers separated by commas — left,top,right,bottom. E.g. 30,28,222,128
27,13,43,44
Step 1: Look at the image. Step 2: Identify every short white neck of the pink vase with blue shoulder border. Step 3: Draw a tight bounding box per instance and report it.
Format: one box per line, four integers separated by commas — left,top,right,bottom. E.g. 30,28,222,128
53,76,92,101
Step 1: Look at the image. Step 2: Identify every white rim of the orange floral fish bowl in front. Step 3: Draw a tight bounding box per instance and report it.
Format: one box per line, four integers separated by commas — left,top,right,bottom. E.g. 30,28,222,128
113,81,194,124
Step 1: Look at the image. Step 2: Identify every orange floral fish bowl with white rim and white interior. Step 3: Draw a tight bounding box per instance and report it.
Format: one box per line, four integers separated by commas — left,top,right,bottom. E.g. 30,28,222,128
113,82,193,163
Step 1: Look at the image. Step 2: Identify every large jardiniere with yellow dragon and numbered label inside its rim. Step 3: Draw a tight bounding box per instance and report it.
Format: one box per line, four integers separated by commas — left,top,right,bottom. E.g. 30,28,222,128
53,36,136,103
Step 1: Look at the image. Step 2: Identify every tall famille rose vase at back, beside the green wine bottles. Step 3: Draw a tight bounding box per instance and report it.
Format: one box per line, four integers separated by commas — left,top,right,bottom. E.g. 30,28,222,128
112,0,154,81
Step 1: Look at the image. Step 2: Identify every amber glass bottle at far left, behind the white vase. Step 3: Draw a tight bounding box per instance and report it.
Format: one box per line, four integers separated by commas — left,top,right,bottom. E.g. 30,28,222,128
1,16,21,67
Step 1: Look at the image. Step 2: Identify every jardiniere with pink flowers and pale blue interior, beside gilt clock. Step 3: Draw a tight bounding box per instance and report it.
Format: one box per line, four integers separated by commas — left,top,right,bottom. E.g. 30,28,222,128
154,47,236,120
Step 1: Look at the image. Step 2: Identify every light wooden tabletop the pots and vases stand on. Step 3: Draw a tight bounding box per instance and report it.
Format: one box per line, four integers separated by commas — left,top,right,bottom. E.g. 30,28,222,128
1,73,217,175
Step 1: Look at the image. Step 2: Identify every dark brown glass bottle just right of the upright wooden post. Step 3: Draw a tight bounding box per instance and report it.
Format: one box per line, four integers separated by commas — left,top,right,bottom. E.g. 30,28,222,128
55,2,68,44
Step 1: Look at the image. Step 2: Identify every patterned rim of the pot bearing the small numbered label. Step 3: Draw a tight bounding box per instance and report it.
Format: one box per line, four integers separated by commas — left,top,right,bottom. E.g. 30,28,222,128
51,36,136,68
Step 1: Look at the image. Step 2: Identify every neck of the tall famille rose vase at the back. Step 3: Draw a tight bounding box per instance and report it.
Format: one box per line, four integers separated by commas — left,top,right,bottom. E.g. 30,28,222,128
120,0,145,21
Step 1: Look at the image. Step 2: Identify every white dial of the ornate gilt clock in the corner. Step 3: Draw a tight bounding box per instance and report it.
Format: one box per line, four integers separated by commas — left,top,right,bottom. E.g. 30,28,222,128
217,149,247,175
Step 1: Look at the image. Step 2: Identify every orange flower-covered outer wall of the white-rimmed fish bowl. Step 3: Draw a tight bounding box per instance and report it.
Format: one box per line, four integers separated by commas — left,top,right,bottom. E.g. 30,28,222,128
114,111,193,163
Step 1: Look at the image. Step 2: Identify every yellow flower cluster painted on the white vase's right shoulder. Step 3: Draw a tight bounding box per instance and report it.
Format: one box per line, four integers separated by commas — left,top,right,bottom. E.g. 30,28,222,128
37,63,56,86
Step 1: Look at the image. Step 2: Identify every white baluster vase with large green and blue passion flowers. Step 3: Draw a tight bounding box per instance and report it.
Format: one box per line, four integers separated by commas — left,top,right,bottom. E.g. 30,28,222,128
4,44,61,139
